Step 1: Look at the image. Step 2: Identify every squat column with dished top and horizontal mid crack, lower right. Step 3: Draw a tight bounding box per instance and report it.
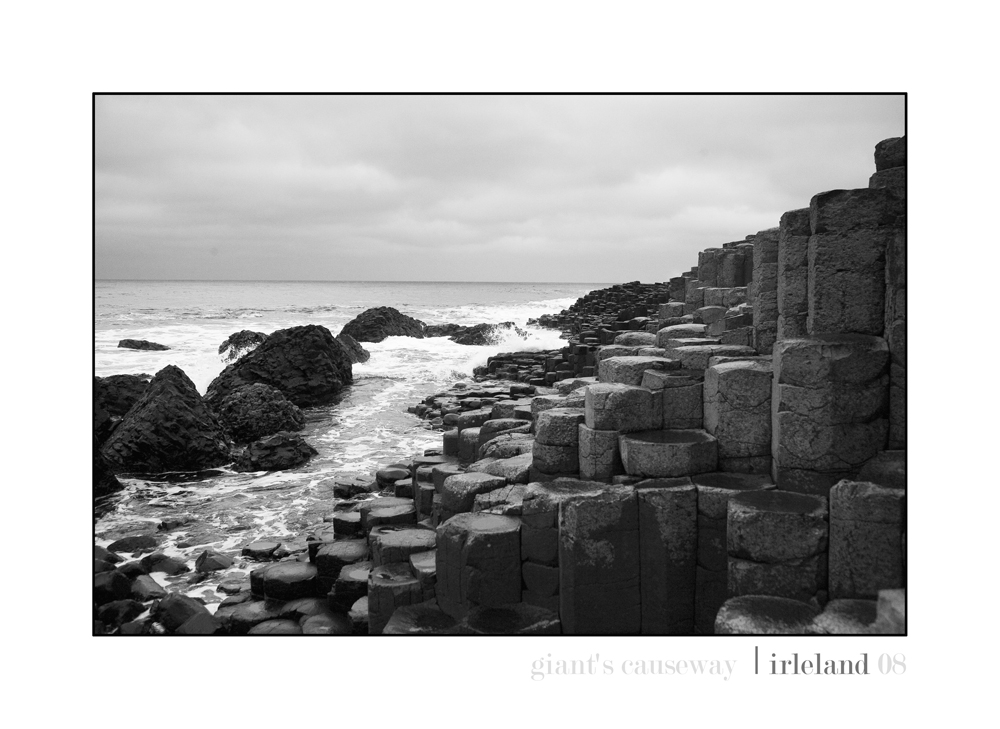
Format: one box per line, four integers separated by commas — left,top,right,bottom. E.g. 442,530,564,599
727,491,829,605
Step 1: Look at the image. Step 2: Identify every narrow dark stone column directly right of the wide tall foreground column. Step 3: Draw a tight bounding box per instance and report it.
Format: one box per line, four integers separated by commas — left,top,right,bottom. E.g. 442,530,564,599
636,477,698,635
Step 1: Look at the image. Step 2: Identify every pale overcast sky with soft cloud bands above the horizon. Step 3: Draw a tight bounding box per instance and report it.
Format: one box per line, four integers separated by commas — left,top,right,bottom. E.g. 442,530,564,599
95,96,904,283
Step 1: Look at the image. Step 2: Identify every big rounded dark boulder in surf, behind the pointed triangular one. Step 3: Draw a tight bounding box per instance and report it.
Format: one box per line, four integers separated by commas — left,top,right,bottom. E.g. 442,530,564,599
205,324,353,407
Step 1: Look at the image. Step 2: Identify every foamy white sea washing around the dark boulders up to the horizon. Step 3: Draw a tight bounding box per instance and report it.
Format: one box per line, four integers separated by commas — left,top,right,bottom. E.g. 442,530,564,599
94,281,609,608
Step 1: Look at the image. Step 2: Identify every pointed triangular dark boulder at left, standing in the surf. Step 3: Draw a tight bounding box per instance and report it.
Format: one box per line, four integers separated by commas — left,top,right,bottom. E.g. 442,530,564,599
101,365,230,473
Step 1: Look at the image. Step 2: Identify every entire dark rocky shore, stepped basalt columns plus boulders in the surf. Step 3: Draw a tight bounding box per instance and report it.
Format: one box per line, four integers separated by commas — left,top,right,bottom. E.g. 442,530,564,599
94,138,906,635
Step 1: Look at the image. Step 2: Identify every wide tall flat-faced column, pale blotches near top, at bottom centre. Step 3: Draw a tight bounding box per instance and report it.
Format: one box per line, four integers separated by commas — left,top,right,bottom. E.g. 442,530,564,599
559,486,642,635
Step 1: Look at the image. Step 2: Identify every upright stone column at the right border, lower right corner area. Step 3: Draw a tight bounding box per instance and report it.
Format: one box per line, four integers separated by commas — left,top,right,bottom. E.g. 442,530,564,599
830,481,906,599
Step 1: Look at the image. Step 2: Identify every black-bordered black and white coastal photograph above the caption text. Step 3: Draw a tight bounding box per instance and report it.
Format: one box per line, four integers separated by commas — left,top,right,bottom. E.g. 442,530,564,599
94,94,906,640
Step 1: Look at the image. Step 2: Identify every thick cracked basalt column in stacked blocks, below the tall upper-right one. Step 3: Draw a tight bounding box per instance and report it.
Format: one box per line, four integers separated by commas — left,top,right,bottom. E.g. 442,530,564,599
771,334,889,496
